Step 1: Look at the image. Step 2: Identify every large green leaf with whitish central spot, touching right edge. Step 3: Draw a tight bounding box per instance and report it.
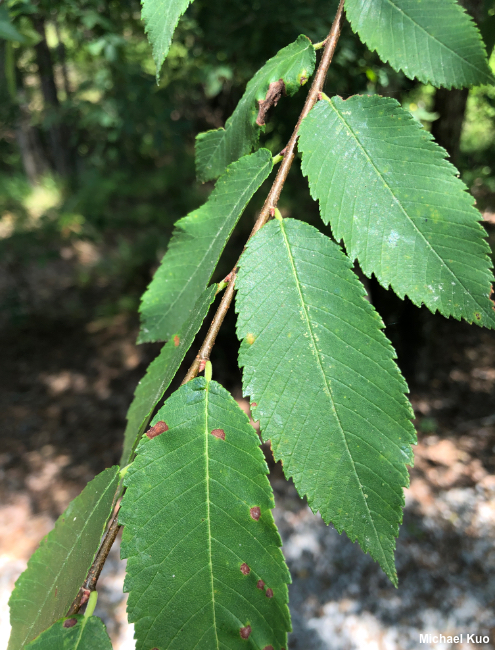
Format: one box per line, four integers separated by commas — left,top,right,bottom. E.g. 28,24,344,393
299,95,495,327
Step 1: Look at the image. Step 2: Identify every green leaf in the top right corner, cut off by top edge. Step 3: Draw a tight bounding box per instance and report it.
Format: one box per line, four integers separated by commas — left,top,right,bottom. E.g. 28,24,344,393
345,0,494,88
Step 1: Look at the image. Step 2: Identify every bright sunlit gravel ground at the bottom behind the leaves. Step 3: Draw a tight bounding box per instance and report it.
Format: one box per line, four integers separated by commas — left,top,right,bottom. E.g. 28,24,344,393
0,441,495,650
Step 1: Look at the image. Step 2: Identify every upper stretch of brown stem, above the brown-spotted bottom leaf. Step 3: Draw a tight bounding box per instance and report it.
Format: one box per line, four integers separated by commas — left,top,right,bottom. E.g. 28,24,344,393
182,0,344,384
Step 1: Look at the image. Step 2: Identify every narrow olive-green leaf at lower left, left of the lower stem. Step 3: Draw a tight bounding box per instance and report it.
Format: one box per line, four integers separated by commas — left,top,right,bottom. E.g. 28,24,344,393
8,466,119,650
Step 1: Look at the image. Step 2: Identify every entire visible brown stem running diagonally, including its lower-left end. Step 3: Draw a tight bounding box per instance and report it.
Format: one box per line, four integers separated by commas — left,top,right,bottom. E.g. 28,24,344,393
67,0,344,604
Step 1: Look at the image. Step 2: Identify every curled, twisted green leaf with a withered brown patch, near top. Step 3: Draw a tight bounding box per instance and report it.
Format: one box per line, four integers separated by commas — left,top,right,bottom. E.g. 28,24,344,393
196,35,316,181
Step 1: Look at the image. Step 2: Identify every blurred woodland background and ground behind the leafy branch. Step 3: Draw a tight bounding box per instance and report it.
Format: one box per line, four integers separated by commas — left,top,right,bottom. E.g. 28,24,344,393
0,0,495,650
